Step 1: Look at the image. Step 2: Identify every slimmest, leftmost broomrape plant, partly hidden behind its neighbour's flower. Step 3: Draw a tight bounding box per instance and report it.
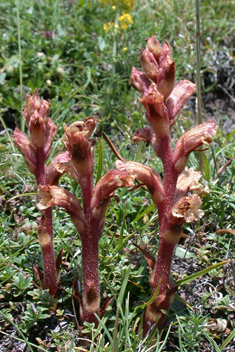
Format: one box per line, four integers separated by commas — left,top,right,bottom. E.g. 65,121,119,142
13,90,60,296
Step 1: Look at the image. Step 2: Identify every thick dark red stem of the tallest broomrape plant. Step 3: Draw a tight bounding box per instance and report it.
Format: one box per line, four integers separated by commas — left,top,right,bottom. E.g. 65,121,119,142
143,136,178,336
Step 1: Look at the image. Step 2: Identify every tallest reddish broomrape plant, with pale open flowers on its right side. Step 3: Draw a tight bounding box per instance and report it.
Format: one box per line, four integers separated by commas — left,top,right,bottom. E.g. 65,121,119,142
116,36,217,336
